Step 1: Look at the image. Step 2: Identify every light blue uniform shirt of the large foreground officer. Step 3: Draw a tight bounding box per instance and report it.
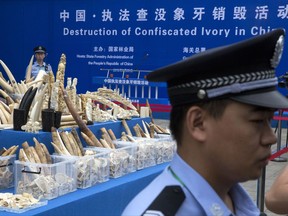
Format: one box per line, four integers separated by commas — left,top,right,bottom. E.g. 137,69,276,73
122,154,260,216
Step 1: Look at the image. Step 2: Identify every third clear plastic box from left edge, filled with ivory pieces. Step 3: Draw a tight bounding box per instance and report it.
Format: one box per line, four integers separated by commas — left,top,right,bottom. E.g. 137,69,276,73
52,148,109,189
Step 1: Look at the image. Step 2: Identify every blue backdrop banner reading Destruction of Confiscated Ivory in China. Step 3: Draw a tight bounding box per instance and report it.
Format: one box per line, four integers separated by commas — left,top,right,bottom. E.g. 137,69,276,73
0,0,288,104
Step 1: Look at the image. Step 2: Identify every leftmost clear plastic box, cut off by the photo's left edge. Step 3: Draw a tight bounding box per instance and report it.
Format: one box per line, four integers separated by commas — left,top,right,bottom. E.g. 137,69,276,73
0,155,16,189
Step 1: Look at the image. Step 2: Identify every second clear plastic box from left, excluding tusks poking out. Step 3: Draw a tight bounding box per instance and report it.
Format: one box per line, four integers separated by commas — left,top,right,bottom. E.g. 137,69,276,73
15,155,77,200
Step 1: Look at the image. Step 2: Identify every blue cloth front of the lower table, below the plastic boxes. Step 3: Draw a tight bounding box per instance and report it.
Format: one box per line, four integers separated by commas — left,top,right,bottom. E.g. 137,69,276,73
0,163,169,216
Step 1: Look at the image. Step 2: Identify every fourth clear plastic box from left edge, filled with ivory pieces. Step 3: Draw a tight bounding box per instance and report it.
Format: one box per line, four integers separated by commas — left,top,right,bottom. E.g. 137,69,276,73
88,146,136,178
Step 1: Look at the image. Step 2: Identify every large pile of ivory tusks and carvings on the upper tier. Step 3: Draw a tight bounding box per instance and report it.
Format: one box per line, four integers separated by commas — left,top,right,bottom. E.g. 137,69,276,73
0,54,156,133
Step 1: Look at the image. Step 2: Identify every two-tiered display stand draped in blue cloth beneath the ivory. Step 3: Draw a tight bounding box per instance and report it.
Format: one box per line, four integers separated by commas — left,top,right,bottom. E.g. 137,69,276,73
0,118,168,216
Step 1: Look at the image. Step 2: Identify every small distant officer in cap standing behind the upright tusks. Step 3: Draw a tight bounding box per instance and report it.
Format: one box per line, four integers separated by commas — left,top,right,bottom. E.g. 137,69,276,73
31,46,52,79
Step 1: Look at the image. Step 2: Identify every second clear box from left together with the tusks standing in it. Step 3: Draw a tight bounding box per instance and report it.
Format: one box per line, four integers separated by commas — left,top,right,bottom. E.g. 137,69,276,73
15,138,76,199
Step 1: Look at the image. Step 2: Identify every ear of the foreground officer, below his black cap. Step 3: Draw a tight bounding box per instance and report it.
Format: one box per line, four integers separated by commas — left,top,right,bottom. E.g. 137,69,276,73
186,106,207,142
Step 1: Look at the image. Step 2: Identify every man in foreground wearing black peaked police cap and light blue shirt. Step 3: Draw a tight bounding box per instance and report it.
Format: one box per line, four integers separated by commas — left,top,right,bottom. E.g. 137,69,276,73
123,29,288,216
